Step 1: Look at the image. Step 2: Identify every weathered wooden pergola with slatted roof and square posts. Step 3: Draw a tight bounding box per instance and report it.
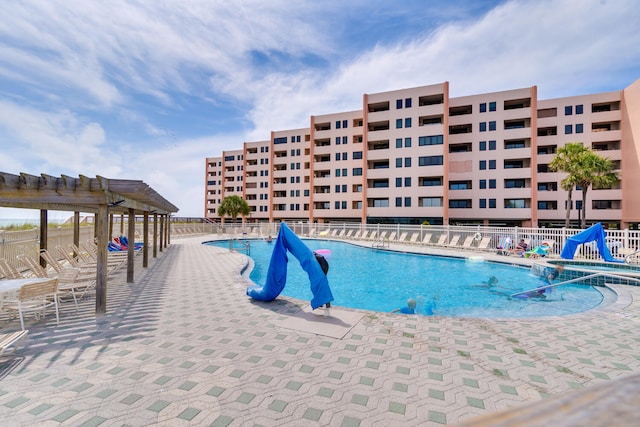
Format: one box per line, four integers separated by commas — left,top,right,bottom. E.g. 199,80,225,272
0,172,178,313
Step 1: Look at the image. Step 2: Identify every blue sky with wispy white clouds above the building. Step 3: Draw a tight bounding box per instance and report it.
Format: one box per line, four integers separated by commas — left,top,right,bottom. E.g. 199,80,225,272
0,0,640,218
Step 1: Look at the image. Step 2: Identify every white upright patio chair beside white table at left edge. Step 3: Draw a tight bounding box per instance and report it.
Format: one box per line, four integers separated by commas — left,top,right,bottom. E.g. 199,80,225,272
3,278,60,331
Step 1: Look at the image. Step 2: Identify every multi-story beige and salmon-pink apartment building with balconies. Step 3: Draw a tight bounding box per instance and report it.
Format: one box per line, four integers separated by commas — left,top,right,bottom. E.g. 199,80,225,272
205,80,640,228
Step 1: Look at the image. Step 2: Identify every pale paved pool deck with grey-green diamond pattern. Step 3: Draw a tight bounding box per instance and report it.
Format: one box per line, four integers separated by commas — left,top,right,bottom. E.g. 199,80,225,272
0,236,640,426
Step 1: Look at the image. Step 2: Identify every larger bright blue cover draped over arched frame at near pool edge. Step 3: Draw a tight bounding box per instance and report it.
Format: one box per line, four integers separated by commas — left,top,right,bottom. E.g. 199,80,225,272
247,222,333,309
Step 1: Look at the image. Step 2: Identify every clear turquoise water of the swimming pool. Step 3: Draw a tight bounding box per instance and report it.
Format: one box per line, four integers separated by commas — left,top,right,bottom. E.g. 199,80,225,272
210,240,603,318
